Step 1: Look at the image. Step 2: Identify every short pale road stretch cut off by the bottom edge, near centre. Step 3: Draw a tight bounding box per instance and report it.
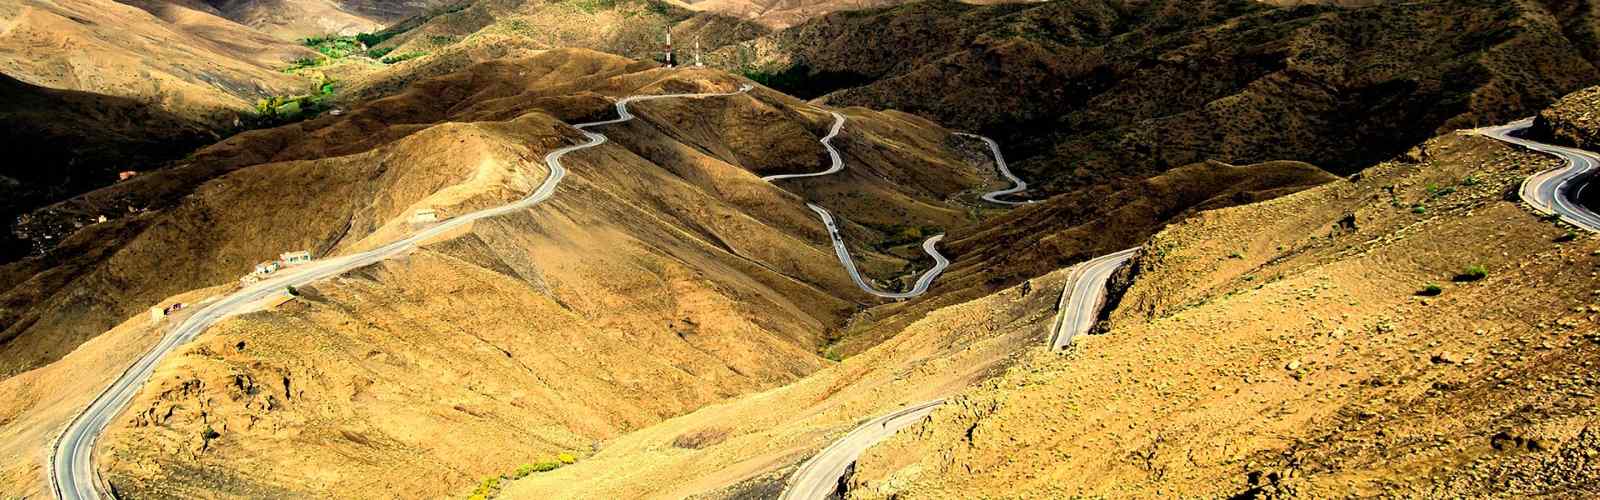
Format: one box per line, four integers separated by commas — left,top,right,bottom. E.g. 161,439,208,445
778,399,944,500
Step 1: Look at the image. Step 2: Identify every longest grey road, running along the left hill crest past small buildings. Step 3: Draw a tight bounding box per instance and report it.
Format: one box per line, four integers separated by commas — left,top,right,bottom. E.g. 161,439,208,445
50,85,752,500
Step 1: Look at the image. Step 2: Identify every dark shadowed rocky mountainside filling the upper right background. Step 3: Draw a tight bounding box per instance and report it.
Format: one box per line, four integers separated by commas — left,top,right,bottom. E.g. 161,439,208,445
715,0,1600,192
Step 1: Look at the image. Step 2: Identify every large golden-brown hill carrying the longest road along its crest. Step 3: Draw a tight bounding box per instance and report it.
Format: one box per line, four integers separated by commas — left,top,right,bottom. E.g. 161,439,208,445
0,50,1030,497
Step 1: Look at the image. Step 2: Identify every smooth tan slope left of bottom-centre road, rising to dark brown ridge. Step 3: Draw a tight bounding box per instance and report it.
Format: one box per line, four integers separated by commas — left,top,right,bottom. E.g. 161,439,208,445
483,163,1328,498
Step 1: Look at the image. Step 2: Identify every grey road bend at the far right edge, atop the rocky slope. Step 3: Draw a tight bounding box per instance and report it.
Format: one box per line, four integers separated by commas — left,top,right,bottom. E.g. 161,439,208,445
1477,119,1600,232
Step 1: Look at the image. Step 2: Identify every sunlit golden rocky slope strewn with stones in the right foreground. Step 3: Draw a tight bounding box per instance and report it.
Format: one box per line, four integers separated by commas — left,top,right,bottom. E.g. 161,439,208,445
850,104,1600,498
